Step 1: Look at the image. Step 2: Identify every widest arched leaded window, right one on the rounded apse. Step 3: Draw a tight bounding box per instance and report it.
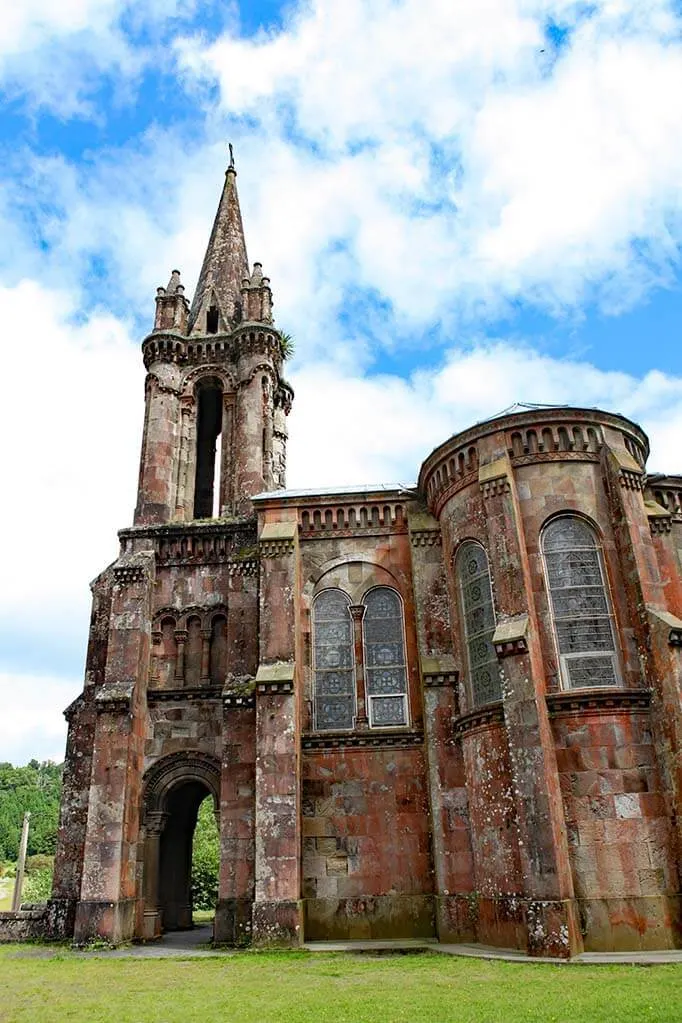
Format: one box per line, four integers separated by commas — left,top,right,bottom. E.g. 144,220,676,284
542,516,619,688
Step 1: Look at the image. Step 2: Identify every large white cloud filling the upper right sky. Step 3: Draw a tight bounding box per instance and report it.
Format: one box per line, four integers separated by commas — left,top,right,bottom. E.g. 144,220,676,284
177,0,682,323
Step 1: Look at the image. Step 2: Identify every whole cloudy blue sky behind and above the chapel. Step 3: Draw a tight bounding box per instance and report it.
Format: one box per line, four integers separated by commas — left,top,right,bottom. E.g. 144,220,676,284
0,0,682,762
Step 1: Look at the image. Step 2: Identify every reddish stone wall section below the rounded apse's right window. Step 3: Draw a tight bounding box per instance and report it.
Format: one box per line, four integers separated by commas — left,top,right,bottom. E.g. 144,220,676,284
552,694,680,951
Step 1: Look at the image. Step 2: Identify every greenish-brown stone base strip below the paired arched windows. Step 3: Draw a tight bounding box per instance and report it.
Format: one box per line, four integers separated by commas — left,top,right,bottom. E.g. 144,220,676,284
304,895,435,941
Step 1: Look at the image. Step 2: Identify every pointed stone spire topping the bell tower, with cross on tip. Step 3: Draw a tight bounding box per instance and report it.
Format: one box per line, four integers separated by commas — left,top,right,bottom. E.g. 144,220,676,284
189,145,248,333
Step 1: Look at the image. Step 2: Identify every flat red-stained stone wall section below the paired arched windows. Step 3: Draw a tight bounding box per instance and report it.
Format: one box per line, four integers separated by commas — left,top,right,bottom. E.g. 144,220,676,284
302,747,434,940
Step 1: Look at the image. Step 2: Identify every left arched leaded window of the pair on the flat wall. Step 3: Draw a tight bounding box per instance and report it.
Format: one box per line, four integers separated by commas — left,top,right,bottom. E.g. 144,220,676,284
313,589,355,730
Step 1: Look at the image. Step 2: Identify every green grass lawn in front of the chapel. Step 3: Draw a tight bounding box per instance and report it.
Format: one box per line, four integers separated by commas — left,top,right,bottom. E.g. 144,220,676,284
0,945,682,1023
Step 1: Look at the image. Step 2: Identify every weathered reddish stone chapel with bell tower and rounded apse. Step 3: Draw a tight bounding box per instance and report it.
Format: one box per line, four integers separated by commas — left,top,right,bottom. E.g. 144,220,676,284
33,155,682,958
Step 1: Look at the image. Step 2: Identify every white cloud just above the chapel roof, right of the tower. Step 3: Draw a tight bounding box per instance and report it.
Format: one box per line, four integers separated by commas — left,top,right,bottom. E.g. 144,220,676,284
287,341,682,488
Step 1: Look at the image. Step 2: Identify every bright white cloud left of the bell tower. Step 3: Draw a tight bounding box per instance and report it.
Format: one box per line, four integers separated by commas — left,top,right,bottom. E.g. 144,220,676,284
0,280,143,636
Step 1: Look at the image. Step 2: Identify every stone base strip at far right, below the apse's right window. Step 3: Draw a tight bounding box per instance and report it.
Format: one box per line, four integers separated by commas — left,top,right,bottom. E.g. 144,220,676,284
576,895,682,952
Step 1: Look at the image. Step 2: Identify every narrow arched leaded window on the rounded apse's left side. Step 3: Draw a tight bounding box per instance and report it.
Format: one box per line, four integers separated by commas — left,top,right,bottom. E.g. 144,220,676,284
456,540,502,708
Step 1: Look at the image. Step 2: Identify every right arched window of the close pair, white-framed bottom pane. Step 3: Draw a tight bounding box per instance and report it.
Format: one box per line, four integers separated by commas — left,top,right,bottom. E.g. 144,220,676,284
363,586,407,728
